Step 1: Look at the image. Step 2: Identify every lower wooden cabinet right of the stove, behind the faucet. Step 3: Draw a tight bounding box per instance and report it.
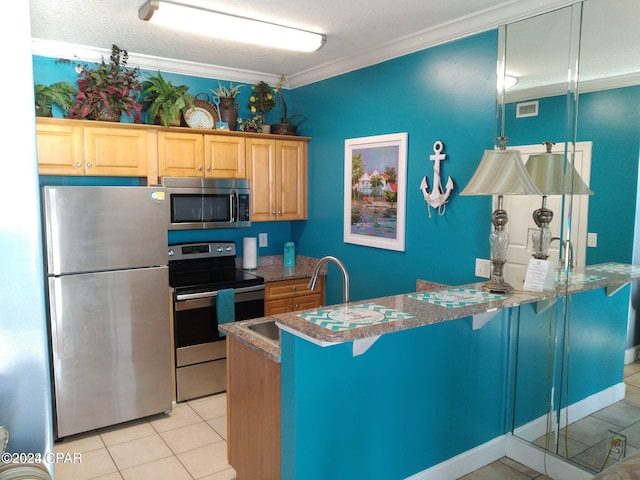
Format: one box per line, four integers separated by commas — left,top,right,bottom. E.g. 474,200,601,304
264,276,324,317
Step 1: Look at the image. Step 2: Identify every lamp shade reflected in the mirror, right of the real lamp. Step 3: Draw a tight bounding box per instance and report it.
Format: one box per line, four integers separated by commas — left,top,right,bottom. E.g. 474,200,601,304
525,153,593,195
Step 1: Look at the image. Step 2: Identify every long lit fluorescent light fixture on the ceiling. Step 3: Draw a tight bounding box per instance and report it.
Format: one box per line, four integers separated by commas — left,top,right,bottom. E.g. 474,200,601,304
138,0,327,52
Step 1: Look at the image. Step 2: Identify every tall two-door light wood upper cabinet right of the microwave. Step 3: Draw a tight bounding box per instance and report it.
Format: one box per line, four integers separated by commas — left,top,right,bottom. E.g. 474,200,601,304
247,138,307,222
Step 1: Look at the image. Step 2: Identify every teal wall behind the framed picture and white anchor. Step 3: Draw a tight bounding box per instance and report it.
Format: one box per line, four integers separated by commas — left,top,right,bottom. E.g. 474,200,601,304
292,31,497,303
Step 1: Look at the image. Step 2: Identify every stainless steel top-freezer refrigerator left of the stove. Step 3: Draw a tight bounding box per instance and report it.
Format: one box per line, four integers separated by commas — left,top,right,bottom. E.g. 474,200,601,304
43,186,172,438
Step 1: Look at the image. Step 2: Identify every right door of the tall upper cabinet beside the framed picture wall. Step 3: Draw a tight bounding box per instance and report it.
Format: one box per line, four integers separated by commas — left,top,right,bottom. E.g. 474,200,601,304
276,140,307,220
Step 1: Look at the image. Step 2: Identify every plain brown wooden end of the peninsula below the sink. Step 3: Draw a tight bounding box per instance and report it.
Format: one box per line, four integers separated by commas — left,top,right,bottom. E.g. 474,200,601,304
227,337,281,480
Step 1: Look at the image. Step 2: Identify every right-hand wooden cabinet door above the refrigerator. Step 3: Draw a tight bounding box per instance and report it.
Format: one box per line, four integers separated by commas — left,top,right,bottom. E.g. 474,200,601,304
84,126,148,177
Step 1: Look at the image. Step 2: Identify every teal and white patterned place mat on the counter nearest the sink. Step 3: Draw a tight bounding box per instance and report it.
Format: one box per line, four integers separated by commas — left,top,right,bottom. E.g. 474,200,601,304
298,303,415,332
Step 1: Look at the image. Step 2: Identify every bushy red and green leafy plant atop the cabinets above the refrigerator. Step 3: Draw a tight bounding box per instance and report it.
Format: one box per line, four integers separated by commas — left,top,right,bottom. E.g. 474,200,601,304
69,45,142,123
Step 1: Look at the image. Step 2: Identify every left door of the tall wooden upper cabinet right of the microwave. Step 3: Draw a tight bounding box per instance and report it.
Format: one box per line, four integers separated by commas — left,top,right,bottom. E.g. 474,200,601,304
247,138,276,222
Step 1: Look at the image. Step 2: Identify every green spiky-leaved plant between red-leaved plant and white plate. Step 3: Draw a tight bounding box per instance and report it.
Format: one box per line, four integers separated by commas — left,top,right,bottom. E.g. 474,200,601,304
140,71,194,127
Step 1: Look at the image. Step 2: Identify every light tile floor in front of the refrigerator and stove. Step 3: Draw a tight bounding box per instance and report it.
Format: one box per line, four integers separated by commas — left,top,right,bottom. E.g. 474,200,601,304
54,394,236,480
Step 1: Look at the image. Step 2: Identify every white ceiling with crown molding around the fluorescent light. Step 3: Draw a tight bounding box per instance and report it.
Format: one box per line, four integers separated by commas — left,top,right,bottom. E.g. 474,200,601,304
29,0,580,87
